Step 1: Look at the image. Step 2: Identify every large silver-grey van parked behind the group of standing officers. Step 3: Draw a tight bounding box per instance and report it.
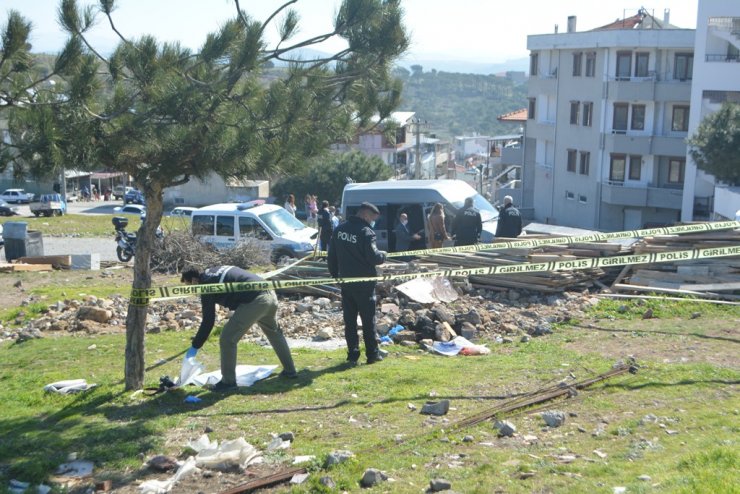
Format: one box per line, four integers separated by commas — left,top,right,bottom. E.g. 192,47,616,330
342,179,498,252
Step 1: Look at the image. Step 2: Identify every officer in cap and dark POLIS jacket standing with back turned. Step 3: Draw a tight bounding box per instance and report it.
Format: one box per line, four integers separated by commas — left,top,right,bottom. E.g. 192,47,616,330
328,202,386,365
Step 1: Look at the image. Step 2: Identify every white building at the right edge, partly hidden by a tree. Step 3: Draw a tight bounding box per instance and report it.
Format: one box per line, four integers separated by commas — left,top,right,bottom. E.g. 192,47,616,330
681,0,740,221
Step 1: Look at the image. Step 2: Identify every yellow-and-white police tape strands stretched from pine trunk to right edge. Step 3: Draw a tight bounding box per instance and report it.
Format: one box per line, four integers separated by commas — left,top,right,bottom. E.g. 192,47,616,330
130,221,740,305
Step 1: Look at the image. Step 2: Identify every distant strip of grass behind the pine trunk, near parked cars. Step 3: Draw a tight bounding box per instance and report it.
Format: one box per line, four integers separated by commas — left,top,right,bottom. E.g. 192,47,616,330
0,214,189,237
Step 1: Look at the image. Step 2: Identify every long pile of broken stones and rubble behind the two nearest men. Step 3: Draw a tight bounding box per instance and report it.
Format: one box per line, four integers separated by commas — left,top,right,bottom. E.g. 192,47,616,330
0,282,597,343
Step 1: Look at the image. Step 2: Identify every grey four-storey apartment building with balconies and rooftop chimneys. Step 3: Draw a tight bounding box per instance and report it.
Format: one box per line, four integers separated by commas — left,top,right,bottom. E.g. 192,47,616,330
525,9,694,231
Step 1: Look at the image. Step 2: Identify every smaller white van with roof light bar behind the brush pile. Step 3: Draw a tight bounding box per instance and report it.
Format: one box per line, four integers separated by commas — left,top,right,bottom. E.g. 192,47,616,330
190,200,316,262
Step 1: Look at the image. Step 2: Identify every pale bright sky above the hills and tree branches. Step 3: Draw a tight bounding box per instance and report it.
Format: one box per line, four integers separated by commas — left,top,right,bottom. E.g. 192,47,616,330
0,0,698,62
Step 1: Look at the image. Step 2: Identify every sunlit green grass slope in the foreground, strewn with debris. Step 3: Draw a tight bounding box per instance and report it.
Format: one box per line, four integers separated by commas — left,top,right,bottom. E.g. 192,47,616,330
0,304,740,493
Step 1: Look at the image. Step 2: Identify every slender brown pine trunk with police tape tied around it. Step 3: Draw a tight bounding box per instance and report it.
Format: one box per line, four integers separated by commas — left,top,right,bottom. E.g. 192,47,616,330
124,185,162,390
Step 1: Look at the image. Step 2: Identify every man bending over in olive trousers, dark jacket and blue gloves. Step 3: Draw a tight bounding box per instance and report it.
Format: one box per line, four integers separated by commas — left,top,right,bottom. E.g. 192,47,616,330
180,266,297,391
